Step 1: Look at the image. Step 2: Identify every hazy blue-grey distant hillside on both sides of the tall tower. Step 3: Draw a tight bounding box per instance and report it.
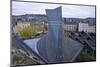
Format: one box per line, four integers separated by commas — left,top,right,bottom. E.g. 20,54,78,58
12,14,96,25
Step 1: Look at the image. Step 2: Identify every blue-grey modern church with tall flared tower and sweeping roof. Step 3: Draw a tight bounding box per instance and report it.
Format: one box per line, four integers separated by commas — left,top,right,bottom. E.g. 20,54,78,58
37,7,83,63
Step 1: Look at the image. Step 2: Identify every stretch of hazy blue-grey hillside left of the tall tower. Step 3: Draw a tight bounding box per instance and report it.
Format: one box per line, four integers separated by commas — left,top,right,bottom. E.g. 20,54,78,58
12,14,47,22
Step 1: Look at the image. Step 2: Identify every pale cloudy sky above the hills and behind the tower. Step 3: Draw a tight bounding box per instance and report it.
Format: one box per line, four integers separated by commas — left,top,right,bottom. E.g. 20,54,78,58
12,1,95,18
